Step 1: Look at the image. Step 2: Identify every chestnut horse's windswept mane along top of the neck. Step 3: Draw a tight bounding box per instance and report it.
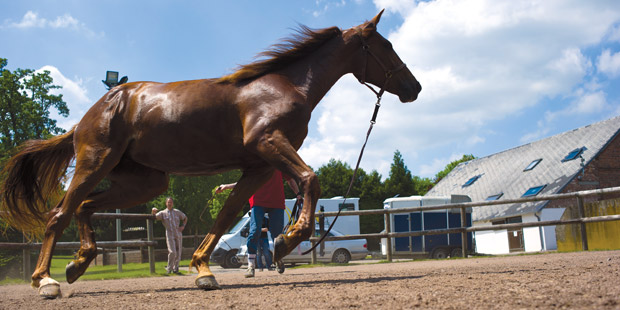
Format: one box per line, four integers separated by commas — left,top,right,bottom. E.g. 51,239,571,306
217,25,342,83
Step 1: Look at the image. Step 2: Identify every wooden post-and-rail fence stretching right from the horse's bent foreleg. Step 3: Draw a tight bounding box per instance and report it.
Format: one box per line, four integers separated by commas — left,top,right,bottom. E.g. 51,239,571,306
310,187,620,263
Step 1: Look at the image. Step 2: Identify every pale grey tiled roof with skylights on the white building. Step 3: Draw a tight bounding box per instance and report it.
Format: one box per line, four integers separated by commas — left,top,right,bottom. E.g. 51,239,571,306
425,117,620,221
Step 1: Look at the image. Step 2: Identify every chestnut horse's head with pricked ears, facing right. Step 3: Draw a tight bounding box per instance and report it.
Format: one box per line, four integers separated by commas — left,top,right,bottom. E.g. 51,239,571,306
351,10,422,102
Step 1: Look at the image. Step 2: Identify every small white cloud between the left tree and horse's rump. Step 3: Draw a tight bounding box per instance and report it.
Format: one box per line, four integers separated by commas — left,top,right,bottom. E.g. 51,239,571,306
37,65,93,130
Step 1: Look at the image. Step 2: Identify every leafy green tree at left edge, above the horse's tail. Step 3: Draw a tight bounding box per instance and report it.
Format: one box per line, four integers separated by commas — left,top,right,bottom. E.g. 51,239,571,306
0,58,69,159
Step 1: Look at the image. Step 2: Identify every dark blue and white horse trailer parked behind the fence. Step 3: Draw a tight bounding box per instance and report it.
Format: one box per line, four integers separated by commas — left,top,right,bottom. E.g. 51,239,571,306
381,195,473,258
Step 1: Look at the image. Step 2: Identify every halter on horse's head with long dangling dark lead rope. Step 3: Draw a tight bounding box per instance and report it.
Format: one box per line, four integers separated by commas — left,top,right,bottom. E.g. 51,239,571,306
295,28,407,255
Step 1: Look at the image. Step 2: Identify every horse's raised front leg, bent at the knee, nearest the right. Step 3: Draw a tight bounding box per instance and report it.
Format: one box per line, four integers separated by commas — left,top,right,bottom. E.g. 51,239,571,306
248,131,321,262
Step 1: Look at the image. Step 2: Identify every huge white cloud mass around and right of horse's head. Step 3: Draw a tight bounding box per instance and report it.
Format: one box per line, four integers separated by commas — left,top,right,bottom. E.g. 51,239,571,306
302,0,620,175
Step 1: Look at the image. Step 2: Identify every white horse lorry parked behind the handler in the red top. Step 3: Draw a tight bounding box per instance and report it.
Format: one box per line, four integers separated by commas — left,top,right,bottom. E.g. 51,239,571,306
210,197,360,268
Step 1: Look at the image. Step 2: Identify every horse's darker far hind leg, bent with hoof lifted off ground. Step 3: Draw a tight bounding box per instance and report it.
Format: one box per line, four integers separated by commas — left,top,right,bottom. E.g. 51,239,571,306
66,160,168,283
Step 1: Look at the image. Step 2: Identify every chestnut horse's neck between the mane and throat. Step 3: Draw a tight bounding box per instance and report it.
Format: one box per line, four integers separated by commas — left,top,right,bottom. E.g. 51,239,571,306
286,39,361,109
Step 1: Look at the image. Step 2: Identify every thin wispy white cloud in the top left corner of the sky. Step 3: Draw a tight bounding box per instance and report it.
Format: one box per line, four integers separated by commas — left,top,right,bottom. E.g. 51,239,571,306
2,11,104,37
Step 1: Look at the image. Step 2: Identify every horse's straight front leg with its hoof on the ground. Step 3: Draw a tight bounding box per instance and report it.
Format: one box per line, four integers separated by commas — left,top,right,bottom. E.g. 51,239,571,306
189,167,273,290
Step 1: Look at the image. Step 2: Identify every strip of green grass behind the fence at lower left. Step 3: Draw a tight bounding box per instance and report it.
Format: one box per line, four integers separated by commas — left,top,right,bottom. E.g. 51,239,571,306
0,256,190,285
